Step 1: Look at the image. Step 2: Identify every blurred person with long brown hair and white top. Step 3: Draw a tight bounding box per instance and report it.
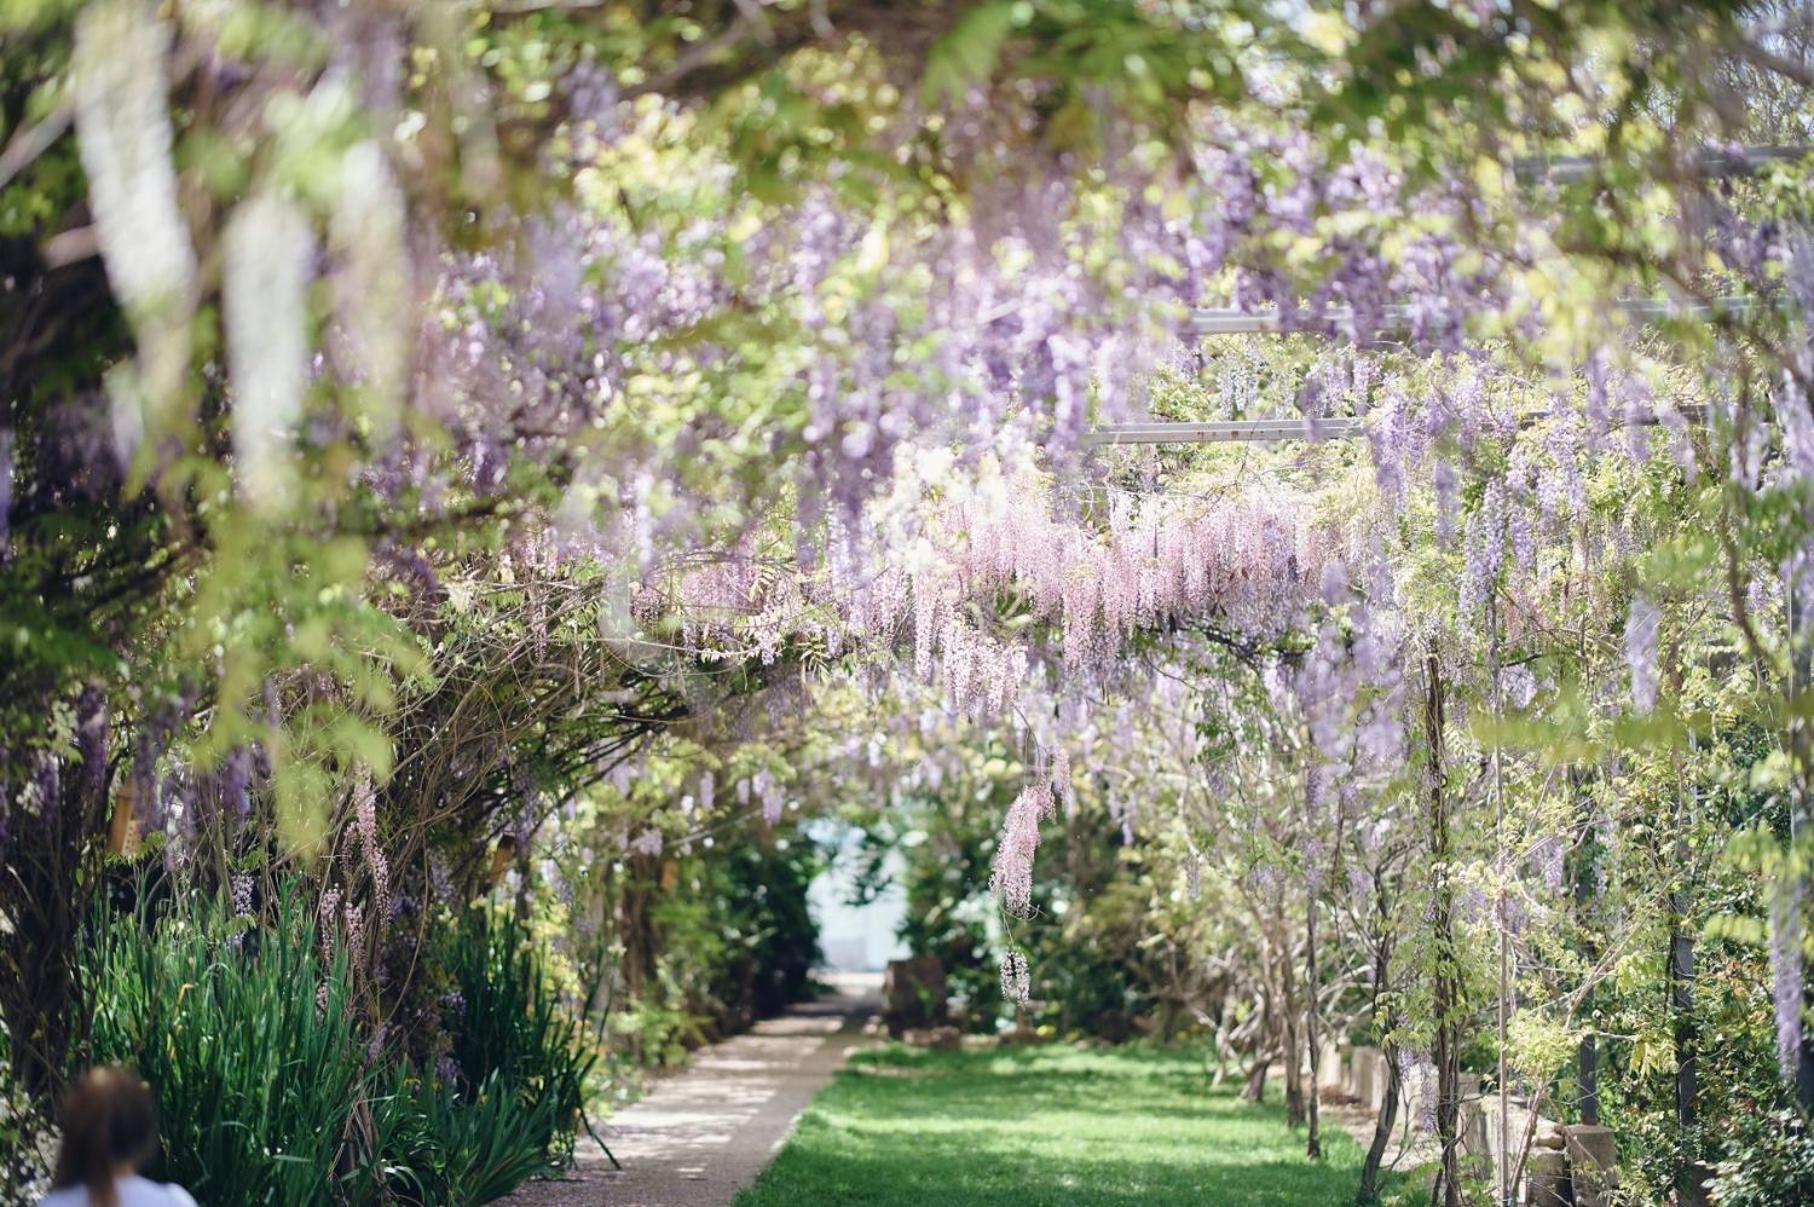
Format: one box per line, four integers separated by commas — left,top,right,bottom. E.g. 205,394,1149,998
38,1065,196,1207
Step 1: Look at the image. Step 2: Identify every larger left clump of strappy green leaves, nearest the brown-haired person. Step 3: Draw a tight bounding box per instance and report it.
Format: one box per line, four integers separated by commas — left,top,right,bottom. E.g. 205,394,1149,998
87,891,379,1203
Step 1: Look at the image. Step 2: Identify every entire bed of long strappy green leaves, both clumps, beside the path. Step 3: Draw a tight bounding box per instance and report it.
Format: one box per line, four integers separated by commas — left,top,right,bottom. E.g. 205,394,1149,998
87,886,591,1205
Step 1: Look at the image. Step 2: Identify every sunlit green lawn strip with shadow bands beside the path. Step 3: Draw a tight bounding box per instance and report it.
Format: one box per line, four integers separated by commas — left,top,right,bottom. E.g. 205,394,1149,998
735,1045,1407,1207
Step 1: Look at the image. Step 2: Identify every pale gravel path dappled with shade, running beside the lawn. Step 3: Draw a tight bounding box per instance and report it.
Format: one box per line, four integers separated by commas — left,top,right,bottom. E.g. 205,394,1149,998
504,976,880,1207
